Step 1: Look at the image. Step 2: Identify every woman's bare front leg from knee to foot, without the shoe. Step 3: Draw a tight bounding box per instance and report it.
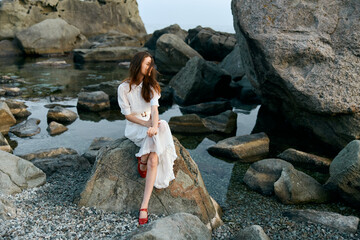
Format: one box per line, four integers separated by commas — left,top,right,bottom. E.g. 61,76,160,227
139,152,159,218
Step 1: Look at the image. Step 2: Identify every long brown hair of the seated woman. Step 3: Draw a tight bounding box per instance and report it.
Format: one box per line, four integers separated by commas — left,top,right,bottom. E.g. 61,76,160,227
128,52,161,102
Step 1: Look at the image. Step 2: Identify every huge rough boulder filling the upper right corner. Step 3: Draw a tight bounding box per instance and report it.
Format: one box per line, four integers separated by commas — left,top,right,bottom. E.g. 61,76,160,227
232,0,360,150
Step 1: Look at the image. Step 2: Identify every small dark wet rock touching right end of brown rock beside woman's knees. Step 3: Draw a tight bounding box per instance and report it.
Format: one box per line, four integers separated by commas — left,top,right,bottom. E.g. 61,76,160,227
204,110,237,134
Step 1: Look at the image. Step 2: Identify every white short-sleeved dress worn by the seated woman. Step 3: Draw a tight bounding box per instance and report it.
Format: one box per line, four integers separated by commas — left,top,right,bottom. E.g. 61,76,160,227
118,81,177,188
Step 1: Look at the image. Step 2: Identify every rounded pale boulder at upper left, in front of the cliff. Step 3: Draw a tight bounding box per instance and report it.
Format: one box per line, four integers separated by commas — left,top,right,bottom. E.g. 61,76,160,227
16,18,86,55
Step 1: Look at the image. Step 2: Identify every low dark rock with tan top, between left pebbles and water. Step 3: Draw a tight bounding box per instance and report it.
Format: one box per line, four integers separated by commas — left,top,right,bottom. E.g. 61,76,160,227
21,148,90,176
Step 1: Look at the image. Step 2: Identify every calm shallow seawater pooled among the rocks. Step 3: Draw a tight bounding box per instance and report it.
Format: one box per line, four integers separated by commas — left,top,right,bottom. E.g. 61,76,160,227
0,57,259,206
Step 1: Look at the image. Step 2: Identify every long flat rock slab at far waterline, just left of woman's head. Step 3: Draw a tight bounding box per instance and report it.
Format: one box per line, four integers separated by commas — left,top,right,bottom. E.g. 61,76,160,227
73,47,147,63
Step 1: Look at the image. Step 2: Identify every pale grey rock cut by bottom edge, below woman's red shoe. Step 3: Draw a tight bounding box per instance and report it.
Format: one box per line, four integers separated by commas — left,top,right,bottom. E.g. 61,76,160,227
125,213,211,240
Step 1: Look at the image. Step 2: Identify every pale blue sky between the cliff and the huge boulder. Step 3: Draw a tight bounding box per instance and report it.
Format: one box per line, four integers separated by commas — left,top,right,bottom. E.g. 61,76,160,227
137,0,235,33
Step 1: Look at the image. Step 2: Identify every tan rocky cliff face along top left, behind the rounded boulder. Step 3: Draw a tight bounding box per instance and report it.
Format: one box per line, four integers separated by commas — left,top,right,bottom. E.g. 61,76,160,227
0,0,146,39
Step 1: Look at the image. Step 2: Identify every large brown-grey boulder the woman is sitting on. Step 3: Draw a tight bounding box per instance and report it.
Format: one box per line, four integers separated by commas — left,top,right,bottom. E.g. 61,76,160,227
79,138,221,228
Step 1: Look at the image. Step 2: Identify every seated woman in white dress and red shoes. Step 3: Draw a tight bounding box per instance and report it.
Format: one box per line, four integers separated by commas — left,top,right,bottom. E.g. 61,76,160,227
118,52,177,225
